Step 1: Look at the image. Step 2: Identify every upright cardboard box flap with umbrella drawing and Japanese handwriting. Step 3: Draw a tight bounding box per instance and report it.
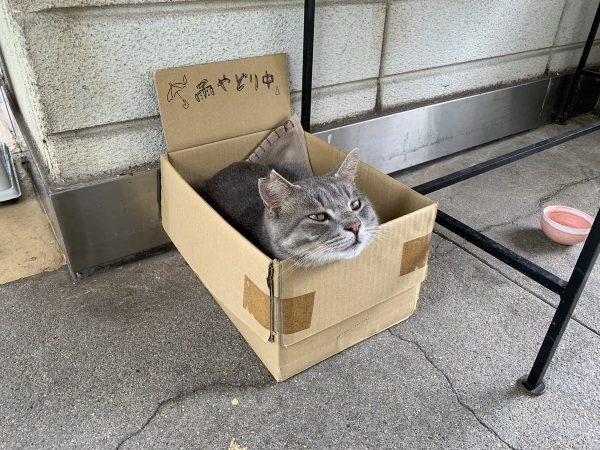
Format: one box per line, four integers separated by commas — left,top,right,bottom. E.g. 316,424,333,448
154,53,291,152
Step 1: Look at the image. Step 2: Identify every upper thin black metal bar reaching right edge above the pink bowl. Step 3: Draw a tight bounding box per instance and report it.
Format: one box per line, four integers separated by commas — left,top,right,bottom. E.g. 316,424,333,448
413,122,600,195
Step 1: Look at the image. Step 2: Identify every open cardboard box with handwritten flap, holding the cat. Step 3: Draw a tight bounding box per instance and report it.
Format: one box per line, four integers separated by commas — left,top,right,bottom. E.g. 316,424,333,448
155,54,436,381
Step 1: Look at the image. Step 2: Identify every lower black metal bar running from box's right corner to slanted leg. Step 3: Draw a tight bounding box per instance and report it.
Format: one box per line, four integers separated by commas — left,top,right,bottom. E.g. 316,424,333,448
435,210,567,294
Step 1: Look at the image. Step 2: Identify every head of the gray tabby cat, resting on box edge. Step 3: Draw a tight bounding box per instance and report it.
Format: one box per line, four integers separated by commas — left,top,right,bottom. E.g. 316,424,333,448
258,150,379,267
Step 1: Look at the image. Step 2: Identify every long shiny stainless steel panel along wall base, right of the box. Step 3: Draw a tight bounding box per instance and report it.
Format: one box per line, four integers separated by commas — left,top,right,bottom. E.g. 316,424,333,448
316,79,558,173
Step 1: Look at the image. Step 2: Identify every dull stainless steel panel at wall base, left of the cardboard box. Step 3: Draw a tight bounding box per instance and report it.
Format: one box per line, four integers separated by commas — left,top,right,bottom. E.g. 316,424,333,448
50,169,169,275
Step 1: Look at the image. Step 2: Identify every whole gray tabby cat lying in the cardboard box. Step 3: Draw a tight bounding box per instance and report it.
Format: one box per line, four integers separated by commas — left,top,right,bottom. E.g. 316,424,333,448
197,150,379,267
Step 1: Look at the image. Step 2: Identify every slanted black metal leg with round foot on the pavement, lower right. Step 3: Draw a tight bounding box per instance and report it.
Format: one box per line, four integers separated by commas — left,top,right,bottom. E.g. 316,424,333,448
519,210,600,395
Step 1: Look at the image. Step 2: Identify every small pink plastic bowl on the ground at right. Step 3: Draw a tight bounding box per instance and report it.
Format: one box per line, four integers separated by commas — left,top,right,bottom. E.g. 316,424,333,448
540,206,594,245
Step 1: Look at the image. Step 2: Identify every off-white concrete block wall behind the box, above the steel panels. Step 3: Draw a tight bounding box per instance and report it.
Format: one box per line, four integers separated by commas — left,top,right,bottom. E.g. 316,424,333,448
0,0,600,186
